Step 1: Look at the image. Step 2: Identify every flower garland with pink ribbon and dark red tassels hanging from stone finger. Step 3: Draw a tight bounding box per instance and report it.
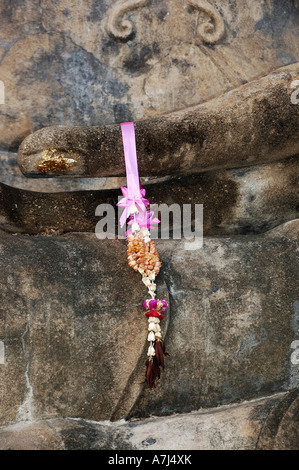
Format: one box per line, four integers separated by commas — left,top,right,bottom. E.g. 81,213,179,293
117,122,169,389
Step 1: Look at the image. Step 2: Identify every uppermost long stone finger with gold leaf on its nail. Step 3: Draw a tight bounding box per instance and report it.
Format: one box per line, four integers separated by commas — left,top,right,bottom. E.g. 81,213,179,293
18,63,299,177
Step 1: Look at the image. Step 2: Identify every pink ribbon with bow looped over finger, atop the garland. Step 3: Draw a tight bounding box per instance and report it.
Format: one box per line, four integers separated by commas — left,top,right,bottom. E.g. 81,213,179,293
117,122,149,227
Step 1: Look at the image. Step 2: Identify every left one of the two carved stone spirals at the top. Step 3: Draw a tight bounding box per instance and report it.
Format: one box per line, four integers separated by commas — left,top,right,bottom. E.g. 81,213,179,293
106,0,148,40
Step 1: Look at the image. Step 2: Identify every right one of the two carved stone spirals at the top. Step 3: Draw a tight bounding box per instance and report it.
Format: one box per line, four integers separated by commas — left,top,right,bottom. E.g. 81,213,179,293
187,0,225,44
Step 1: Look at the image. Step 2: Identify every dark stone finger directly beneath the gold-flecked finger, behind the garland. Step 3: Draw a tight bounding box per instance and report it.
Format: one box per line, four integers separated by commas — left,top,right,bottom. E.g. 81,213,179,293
0,157,299,235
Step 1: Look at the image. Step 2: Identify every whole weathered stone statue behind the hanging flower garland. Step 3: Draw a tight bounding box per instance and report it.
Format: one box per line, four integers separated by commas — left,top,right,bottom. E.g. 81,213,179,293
0,0,299,450
